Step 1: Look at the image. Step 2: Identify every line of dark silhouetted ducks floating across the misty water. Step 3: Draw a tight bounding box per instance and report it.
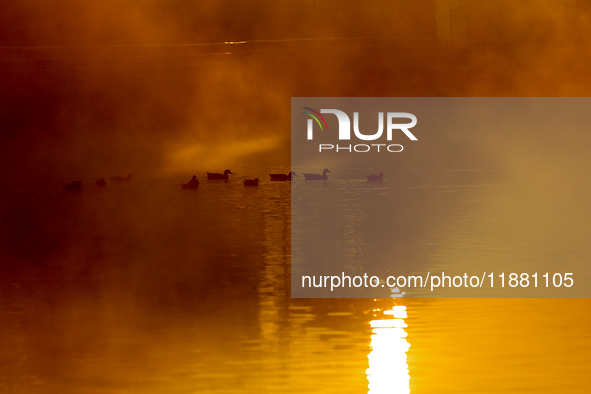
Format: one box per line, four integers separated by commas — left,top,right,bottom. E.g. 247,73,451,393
64,168,384,191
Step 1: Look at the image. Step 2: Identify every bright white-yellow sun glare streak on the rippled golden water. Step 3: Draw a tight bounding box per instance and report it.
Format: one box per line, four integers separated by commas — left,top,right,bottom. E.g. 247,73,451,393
366,305,410,394
